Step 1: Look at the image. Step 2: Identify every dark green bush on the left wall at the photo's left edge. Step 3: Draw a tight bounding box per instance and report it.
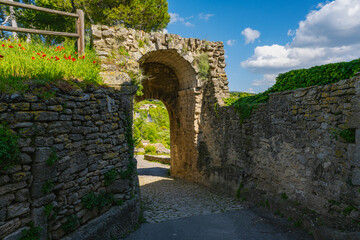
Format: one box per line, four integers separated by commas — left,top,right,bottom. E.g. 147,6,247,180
0,124,20,170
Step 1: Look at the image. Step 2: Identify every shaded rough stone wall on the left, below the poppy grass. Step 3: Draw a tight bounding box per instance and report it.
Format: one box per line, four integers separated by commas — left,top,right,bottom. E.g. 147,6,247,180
0,87,139,239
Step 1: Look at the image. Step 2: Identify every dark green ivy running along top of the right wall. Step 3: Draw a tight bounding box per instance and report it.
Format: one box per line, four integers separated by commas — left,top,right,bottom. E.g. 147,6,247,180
225,59,360,124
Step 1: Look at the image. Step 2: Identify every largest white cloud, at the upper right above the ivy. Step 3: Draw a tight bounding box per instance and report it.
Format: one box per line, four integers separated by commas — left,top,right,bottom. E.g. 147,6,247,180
241,0,360,86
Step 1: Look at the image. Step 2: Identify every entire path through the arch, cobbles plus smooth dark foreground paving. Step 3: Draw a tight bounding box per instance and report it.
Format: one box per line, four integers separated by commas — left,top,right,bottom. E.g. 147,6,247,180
126,156,313,240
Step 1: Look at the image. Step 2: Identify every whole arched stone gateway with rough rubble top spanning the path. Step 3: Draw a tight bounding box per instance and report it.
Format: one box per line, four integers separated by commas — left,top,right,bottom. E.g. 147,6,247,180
92,26,229,181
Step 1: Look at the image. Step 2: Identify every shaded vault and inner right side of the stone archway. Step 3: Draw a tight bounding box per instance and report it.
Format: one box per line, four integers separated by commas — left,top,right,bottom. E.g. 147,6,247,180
136,50,200,176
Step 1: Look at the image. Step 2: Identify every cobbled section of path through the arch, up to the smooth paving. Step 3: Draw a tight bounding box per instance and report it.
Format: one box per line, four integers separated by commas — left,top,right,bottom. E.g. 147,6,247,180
138,156,243,223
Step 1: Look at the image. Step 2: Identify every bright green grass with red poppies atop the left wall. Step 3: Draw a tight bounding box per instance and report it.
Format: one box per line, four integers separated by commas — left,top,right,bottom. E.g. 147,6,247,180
0,39,102,93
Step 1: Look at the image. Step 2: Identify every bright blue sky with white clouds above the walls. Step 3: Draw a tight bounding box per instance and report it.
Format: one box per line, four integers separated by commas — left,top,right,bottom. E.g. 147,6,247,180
167,0,360,92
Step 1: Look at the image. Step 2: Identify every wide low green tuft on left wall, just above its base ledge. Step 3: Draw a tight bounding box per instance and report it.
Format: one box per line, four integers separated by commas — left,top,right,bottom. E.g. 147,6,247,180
81,192,114,209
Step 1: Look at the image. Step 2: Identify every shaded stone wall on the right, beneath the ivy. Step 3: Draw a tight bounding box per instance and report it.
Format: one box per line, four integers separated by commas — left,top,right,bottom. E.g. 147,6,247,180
198,75,360,229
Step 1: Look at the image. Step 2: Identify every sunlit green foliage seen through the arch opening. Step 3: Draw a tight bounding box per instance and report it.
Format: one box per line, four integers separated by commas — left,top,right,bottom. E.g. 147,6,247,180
134,100,170,148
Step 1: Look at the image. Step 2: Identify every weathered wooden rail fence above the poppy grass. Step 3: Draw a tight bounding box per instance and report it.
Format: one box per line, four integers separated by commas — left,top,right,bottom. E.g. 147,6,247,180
0,0,85,54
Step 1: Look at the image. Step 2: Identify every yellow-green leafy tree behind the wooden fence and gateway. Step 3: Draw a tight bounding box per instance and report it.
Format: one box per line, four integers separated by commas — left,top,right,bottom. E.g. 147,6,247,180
17,0,170,35
